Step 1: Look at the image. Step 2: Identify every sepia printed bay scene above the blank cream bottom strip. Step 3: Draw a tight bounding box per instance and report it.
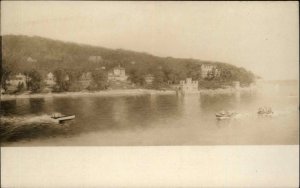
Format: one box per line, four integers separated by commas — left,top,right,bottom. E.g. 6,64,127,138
0,1,299,187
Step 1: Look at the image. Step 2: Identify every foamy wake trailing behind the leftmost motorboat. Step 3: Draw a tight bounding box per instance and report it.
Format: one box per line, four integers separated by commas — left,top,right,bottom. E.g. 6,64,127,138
0,115,69,142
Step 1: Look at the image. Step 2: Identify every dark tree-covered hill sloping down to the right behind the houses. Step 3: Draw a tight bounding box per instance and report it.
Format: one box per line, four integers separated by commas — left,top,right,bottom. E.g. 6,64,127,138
1,35,254,89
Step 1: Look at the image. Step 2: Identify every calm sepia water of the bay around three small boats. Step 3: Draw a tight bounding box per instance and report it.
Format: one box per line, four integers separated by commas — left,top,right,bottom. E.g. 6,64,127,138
0,82,299,146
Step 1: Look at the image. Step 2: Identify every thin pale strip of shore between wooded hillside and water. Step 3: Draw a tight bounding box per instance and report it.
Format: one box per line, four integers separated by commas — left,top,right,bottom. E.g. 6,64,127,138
0,88,255,101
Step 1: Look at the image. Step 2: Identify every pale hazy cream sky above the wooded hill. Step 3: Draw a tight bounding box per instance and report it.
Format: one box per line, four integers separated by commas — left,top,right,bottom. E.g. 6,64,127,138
1,1,299,79
